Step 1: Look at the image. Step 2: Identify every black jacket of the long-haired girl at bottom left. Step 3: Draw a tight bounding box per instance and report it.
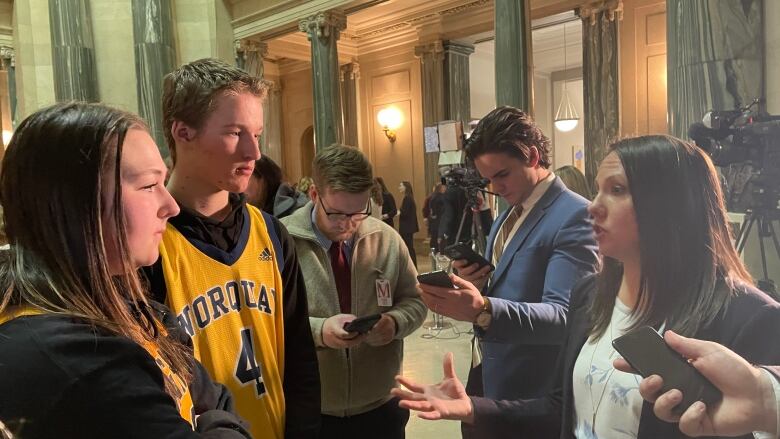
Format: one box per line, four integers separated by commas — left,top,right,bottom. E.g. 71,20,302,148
0,315,250,439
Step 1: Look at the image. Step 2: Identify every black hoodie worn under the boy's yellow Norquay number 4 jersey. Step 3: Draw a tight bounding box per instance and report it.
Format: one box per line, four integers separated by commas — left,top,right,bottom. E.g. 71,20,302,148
144,194,320,438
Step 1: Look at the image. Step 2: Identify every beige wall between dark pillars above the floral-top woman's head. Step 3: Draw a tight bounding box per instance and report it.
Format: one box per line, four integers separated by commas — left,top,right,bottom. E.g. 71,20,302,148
618,0,668,135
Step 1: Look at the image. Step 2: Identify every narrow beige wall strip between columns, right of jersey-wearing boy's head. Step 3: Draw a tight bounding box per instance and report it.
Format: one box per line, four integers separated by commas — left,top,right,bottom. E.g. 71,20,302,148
280,69,314,181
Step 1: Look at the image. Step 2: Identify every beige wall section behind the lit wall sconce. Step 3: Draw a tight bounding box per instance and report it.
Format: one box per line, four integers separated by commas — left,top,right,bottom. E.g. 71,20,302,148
358,45,430,234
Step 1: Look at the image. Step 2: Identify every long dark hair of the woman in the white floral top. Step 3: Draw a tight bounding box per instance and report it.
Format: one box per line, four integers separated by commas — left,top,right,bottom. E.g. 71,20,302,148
591,135,752,336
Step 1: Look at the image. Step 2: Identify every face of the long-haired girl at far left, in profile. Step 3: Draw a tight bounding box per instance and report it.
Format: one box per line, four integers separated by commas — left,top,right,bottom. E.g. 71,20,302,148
103,128,179,274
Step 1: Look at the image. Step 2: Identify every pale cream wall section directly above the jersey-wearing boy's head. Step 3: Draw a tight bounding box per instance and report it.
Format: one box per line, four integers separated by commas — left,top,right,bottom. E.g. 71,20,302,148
174,0,235,65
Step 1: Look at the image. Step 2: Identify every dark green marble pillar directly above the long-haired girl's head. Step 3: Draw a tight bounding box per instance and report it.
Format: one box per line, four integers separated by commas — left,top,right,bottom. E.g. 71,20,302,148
49,0,100,102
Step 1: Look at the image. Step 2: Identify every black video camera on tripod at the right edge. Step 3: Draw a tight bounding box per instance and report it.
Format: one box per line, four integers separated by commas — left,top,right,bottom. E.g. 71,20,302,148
688,99,780,210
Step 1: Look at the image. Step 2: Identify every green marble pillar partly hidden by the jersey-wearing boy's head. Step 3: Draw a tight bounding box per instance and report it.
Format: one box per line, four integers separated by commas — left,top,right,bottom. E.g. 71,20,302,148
133,0,176,157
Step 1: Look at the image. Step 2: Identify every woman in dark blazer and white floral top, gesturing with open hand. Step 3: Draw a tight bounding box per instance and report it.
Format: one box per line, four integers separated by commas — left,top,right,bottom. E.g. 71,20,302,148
393,136,780,439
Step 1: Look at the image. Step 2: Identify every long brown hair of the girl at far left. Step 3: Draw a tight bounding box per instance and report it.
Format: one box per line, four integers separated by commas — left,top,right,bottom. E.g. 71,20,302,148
0,103,191,395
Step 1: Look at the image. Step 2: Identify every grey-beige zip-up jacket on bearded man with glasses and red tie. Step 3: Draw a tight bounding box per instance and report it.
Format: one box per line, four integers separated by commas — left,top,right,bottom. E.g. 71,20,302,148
281,202,427,417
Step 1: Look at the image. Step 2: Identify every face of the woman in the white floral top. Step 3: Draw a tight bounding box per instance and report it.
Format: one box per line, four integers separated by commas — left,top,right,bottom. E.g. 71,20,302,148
588,152,639,263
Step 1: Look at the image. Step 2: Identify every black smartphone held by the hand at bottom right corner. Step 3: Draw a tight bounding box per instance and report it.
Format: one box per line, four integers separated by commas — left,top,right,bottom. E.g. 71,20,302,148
612,326,723,414
